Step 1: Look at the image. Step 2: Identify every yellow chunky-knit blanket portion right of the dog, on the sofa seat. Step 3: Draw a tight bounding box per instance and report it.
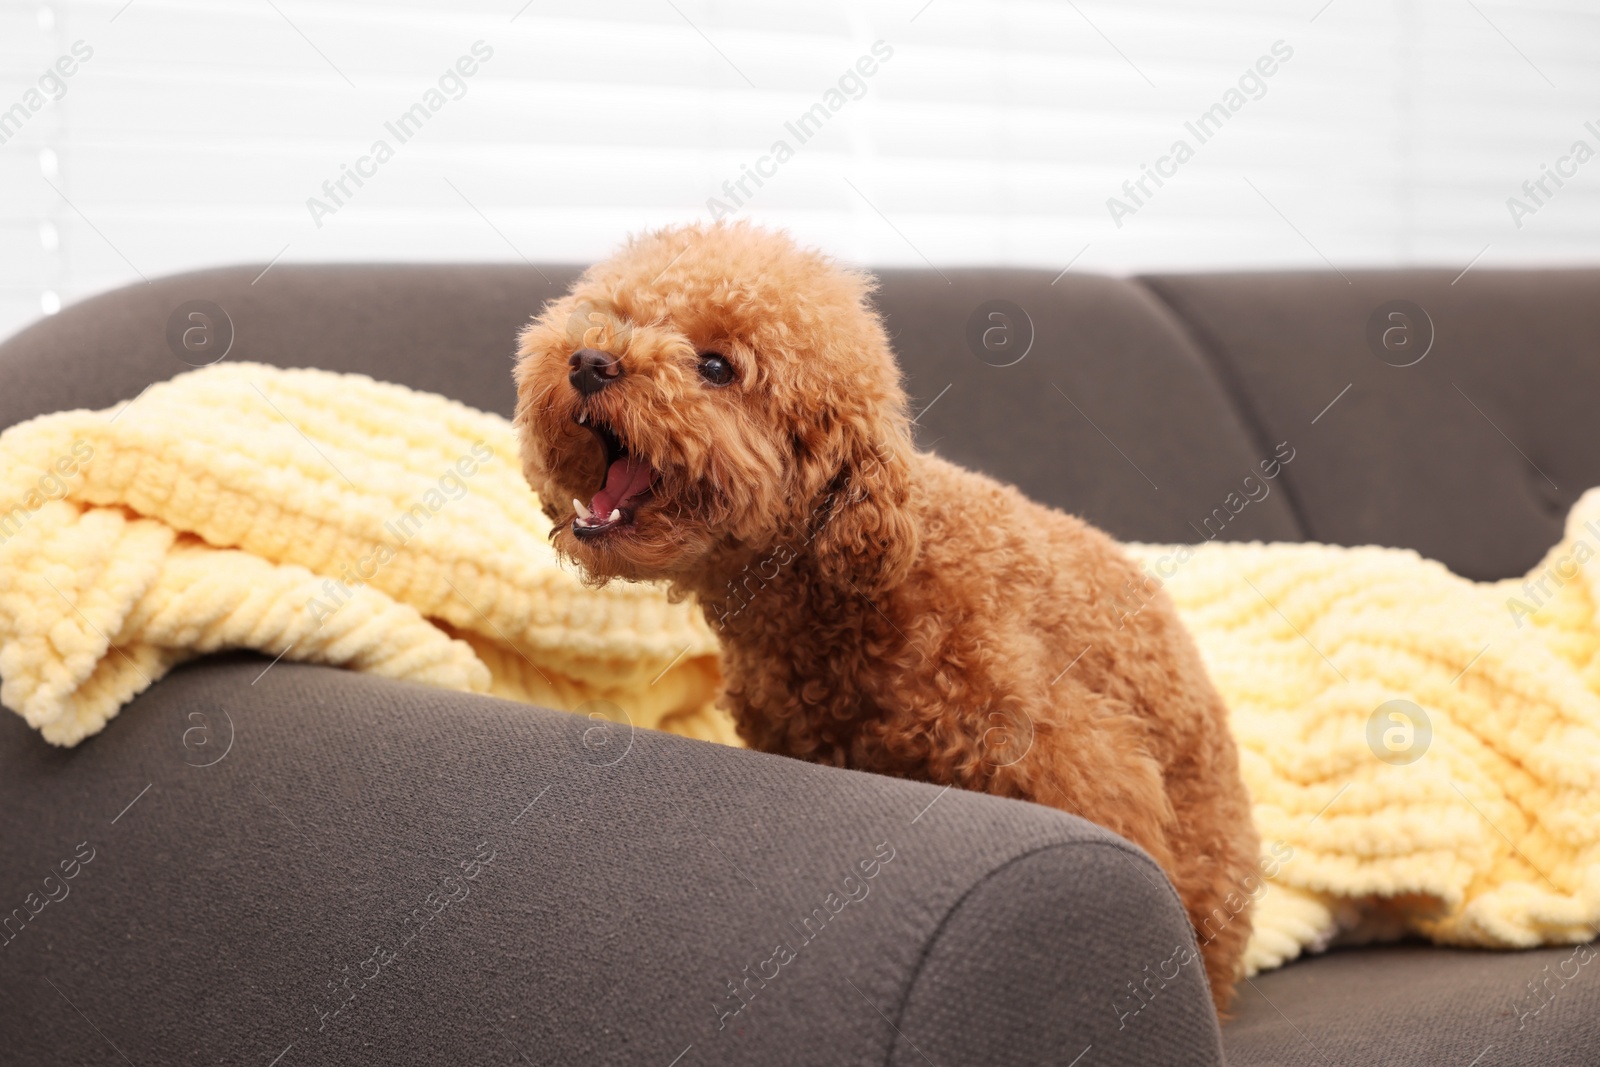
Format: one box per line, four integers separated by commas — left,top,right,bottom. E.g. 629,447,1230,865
1130,502,1600,971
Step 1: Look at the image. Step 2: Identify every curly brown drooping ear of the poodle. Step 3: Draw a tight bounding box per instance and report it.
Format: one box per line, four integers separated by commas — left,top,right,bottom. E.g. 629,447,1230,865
811,413,920,597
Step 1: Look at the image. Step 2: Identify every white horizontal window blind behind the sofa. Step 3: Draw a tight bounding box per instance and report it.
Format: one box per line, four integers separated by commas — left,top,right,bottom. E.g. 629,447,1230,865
0,0,1600,342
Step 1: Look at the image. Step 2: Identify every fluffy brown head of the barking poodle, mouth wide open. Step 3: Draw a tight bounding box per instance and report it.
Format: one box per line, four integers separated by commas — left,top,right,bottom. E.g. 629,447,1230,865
517,224,917,592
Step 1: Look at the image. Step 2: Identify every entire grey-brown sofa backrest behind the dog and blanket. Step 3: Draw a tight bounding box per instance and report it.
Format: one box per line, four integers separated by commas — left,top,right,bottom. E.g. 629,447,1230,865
0,264,1600,577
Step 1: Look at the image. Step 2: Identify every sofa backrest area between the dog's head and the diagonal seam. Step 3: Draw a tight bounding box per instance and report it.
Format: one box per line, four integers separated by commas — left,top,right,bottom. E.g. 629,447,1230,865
877,269,1304,542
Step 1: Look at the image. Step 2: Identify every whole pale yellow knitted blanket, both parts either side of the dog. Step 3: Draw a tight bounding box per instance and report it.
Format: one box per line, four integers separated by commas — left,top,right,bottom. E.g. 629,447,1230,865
0,363,1600,971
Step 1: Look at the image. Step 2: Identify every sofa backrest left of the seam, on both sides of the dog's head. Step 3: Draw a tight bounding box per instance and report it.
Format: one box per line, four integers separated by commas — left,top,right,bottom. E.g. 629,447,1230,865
0,264,1304,541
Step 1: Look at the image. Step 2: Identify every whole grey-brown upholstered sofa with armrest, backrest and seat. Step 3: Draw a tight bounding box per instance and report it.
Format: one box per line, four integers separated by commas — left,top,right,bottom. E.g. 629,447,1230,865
0,264,1600,1067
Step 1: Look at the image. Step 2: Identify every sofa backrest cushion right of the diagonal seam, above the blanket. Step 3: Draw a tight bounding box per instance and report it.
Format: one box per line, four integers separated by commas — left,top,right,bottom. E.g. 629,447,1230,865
1146,269,1600,579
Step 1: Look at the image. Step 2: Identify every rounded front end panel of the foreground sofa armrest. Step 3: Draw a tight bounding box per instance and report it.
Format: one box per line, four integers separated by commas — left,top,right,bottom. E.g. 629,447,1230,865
891,840,1222,1067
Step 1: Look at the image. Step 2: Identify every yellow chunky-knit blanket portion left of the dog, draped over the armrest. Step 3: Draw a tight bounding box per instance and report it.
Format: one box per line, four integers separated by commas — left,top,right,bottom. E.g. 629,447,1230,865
0,363,734,745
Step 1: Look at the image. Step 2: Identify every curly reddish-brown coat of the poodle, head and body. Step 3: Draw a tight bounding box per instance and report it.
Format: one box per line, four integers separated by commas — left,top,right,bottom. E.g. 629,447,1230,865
515,224,1259,1009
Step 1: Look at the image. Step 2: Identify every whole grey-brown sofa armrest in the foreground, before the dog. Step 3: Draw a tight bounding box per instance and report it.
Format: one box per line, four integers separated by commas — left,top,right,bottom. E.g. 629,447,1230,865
0,654,1221,1067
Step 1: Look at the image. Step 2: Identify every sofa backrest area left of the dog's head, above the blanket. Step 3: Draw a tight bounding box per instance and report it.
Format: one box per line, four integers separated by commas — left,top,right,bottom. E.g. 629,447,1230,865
0,264,578,429
